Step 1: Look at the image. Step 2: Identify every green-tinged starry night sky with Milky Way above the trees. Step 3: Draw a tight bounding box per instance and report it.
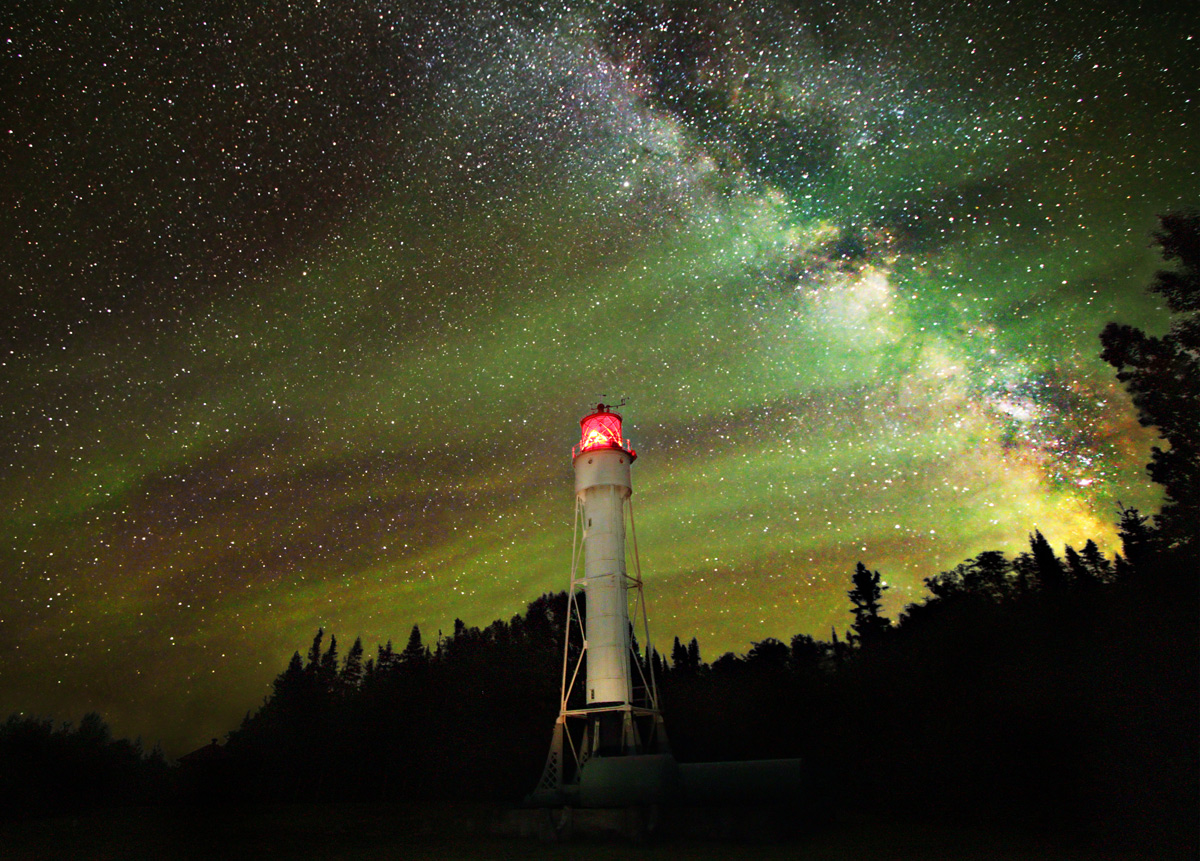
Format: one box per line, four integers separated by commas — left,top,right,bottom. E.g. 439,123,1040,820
0,0,1200,754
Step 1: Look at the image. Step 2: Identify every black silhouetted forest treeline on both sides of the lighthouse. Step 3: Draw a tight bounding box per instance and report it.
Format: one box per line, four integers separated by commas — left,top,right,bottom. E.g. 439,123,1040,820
0,211,1200,842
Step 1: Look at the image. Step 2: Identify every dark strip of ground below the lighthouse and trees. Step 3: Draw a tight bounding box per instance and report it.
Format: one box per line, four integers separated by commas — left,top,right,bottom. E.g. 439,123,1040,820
0,805,1190,861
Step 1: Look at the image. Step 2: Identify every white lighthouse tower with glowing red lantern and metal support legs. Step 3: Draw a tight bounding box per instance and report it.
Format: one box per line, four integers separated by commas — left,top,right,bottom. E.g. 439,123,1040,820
532,402,677,806
